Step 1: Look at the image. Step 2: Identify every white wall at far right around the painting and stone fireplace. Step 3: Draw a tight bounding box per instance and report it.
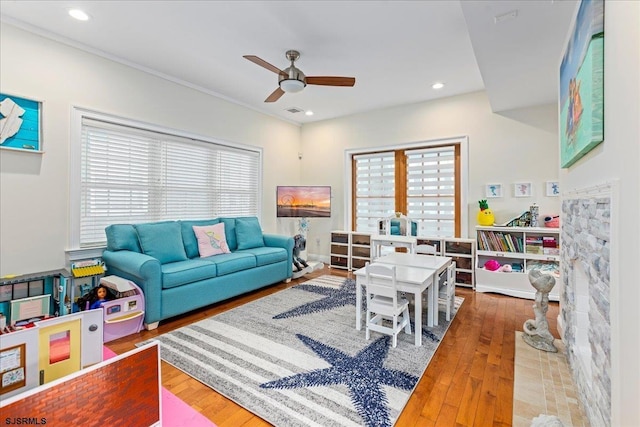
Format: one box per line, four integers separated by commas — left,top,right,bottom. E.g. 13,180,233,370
560,1,640,426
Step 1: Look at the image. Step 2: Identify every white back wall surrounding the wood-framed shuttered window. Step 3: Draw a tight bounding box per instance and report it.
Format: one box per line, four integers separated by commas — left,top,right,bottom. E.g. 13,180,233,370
301,92,560,254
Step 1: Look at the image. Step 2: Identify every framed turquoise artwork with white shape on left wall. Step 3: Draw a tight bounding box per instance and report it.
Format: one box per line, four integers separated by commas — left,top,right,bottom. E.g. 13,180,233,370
0,93,42,152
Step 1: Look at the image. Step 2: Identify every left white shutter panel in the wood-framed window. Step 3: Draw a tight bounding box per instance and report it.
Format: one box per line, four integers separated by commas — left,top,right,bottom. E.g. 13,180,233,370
353,152,395,232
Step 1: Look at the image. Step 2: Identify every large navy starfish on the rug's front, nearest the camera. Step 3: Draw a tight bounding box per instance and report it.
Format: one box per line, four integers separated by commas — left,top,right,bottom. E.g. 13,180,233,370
260,334,419,427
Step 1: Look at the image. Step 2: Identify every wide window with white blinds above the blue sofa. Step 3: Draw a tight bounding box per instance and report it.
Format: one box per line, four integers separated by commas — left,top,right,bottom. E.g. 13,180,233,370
79,117,261,248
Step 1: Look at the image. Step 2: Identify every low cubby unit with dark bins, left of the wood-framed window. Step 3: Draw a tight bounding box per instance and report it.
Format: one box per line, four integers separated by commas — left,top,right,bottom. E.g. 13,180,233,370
330,231,371,271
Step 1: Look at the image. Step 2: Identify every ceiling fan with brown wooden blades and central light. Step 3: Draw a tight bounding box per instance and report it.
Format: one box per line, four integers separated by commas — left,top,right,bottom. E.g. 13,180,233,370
243,50,356,102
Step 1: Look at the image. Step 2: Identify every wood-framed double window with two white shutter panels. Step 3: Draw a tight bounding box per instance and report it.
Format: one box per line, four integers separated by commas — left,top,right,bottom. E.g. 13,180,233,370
351,138,467,237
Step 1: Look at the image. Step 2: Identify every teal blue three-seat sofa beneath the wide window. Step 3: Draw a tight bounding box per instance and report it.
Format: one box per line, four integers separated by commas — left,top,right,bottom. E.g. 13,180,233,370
102,217,293,329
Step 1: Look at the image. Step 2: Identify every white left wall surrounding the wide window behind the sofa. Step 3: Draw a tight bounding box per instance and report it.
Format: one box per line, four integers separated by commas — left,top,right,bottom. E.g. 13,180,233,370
0,22,300,275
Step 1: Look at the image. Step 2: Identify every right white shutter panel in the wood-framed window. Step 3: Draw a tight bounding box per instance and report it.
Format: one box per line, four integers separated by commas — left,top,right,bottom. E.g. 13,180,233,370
405,146,456,237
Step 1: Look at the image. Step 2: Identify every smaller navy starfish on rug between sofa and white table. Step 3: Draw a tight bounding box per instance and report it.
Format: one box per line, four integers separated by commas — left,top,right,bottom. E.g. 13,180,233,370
273,279,356,319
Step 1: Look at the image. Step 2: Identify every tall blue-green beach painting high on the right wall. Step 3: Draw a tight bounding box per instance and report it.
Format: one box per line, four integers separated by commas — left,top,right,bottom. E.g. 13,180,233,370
559,0,604,168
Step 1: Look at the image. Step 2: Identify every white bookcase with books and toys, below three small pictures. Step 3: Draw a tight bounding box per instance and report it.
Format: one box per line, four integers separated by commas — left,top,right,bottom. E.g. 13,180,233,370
475,226,560,301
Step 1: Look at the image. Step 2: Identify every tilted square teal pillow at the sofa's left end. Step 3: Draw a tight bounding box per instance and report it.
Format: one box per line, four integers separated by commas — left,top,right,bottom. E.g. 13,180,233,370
135,221,187,264
